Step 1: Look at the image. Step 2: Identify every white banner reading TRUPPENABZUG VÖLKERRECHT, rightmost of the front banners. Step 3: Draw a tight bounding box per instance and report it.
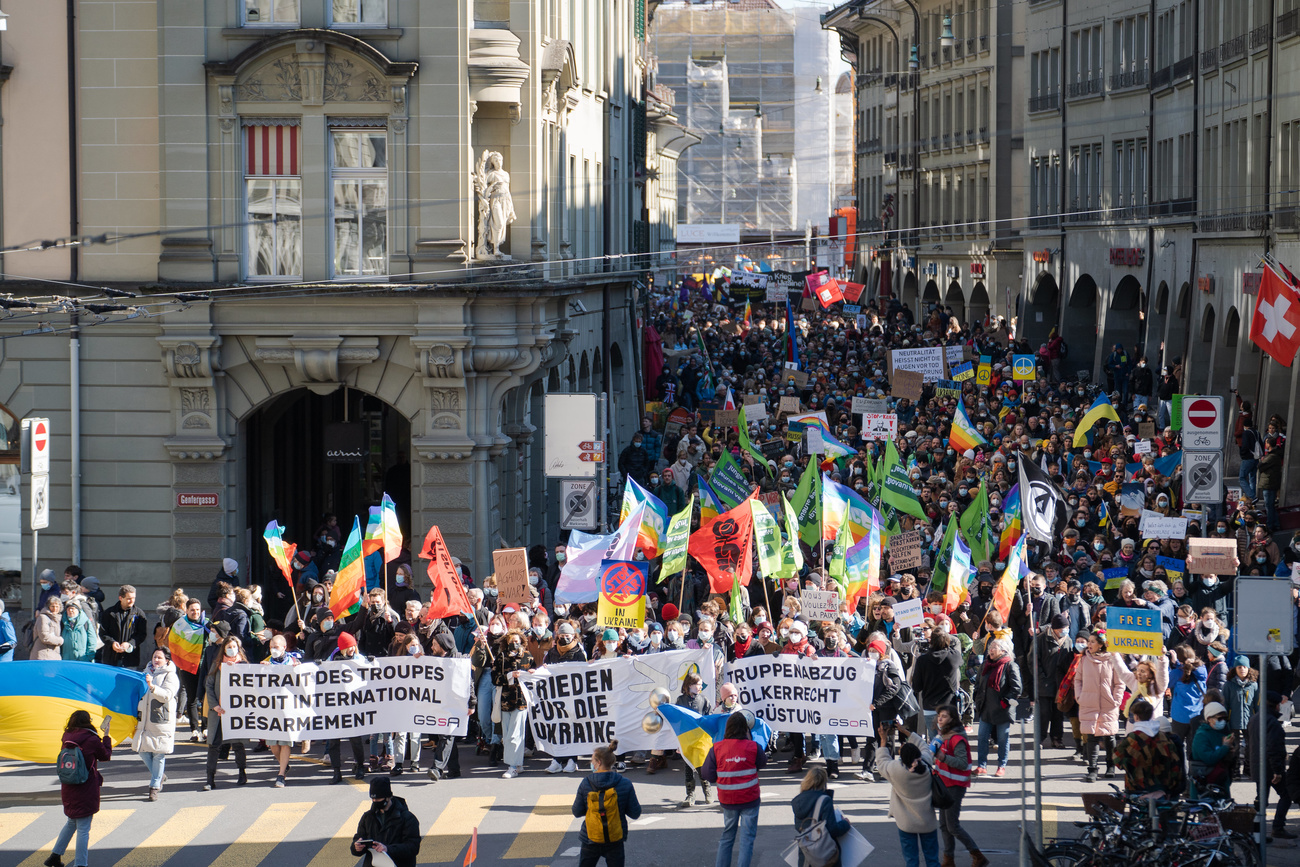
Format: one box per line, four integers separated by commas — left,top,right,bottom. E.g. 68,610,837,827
725,654,876,737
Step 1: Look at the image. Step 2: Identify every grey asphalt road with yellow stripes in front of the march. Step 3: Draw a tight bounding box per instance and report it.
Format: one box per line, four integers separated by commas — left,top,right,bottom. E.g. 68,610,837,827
0,729,1300,867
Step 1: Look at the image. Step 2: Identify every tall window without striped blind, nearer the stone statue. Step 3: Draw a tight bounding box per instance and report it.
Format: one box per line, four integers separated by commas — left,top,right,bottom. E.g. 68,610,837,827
330,129,389,277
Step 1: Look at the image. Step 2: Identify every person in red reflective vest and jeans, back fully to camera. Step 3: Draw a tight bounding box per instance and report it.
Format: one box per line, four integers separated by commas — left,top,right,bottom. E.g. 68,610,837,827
699,711,767,867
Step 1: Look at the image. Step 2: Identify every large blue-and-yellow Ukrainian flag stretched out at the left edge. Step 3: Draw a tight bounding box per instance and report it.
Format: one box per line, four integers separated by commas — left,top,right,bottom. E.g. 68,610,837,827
0,660,147,763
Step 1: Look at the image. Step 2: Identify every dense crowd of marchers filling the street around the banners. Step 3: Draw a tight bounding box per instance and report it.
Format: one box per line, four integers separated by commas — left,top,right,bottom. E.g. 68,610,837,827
0,287,1300,867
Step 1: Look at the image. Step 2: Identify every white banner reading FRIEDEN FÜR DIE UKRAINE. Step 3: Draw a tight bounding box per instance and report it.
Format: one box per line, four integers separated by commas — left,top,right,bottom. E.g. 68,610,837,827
519,650,716,758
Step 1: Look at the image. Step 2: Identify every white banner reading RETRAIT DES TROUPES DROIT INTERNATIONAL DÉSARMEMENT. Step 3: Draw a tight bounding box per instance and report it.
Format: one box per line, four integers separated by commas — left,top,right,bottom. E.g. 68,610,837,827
221,656,473,741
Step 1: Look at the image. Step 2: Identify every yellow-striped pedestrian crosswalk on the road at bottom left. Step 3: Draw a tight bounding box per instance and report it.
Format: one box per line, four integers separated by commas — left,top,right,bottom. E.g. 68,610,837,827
0,785,579,867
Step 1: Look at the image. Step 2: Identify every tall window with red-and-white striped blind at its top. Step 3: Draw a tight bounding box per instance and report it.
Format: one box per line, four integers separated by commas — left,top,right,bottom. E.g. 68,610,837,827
243,123,303,279
